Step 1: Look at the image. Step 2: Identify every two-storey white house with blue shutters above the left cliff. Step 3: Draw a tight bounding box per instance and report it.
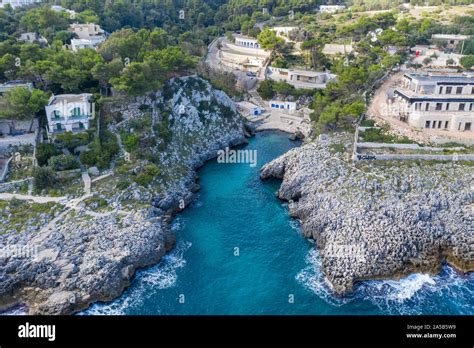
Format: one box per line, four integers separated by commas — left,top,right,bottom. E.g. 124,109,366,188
46,93,95,135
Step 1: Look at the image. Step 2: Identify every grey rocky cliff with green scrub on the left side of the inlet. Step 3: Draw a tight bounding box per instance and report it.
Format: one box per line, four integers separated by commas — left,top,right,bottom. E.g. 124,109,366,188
0,77,245,314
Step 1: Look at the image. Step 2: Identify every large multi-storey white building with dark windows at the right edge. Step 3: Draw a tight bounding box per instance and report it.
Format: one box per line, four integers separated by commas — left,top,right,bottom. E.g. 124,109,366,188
392,73,474,132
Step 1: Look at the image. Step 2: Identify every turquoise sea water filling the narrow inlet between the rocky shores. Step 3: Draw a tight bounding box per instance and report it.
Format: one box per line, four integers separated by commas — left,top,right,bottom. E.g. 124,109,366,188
82,132,474,315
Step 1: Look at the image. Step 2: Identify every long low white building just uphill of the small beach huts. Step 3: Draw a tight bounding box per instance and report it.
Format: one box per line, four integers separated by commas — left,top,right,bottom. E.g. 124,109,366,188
267,66,335,89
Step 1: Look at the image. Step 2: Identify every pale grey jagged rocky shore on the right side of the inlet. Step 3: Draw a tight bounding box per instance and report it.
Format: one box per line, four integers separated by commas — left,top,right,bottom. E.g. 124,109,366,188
260,134,474,295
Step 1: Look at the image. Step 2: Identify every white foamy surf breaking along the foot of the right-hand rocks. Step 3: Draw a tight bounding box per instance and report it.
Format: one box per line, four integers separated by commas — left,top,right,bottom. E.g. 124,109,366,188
296,249,474,315
